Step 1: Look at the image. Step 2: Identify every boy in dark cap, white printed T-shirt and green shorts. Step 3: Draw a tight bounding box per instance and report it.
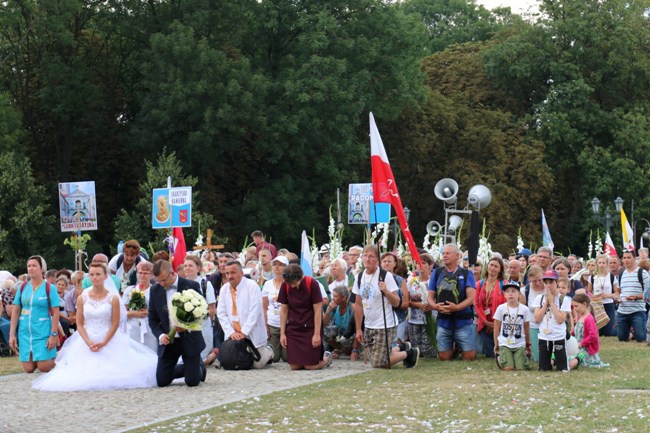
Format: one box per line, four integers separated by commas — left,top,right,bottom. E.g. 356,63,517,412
493,281,530,371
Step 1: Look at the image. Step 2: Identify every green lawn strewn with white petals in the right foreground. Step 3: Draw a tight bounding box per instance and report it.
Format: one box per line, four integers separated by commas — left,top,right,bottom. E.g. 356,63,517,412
132,337,650,433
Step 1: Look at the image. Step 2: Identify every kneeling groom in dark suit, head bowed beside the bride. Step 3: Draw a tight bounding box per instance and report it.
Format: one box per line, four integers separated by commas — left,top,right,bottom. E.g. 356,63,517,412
149,260,206,386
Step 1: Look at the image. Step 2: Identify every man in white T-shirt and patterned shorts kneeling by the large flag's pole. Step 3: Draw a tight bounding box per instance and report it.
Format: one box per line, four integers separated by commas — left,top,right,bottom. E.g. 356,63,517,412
352,245,420,368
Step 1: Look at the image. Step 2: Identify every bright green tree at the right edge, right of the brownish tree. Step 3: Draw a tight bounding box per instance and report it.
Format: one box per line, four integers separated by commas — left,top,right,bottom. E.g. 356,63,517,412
485,0,650,252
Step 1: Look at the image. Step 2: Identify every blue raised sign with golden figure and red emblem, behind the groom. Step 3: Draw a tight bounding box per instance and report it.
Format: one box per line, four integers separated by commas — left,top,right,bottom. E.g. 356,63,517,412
151,186,192,229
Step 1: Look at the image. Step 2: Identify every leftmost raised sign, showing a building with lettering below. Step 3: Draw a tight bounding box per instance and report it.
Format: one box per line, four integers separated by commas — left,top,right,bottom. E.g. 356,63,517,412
59,181,97,232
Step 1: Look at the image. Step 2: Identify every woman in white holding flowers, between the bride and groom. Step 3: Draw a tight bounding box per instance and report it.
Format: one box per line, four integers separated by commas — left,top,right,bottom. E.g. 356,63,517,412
122,260,158,351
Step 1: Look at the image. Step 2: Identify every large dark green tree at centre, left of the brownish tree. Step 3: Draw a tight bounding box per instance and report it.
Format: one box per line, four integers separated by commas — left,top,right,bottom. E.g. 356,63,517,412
132,0,424,247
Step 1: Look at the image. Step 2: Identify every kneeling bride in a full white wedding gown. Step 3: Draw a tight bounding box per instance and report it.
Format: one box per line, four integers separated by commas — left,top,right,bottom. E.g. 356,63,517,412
32,262,157,391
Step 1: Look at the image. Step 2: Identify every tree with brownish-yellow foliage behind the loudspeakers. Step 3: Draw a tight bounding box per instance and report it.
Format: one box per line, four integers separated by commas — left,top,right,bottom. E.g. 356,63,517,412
379,42,553,253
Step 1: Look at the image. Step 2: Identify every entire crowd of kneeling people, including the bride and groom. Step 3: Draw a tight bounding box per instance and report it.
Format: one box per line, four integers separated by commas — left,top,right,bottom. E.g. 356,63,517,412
0,231,650,391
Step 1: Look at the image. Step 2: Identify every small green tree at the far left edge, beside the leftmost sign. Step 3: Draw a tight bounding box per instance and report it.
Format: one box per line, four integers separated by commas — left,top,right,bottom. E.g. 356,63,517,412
0,152,56,273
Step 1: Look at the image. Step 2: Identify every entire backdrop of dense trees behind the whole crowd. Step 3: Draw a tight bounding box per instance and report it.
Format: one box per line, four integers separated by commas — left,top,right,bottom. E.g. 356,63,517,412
0,0,650,267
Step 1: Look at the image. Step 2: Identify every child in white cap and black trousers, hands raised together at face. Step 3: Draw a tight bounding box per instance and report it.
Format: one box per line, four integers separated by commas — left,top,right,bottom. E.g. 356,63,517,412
533,270,571,371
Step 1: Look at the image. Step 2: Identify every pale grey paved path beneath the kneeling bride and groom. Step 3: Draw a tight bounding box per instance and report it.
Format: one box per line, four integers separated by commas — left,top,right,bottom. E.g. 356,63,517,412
0,360,370,433
